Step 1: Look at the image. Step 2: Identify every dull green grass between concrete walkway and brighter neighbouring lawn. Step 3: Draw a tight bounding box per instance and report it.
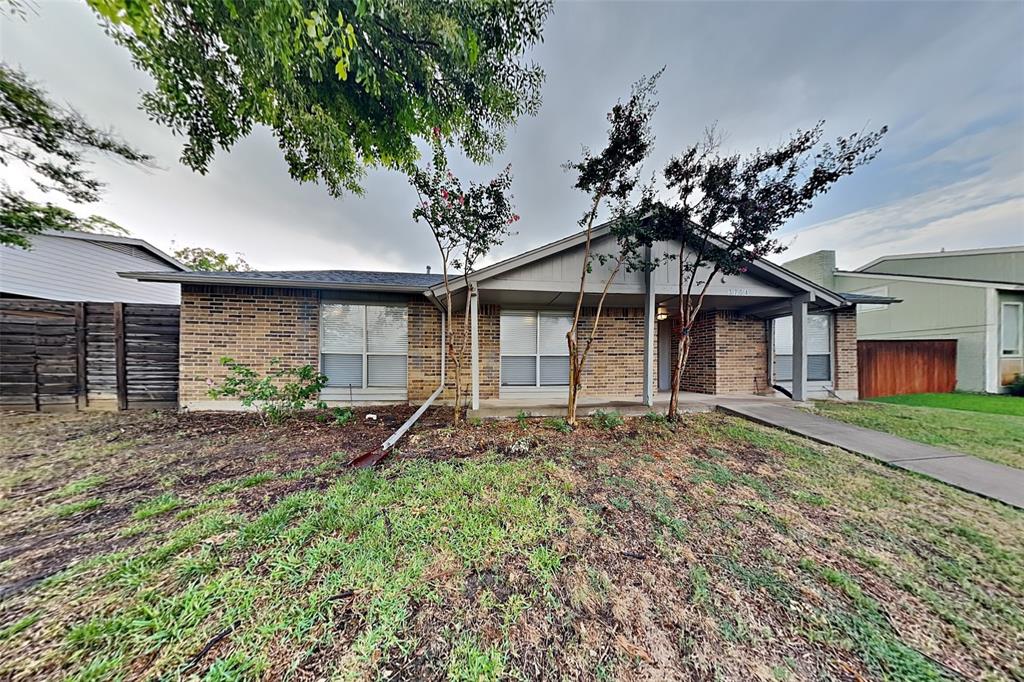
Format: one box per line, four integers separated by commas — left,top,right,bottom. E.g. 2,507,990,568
813,396,1024,469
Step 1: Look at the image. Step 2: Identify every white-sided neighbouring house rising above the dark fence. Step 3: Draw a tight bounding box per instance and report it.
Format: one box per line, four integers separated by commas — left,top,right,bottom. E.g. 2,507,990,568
0,231,187,303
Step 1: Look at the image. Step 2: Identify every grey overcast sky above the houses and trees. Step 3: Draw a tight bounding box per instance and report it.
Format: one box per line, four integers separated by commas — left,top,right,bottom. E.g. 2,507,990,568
0,0,1024,271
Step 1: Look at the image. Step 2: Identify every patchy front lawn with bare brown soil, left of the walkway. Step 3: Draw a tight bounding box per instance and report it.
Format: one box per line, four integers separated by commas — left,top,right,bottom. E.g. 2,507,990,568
0,411,1024,680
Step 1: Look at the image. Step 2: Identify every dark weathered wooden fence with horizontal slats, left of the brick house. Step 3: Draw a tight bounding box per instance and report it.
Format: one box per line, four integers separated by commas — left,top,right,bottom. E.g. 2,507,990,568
0,299,179,411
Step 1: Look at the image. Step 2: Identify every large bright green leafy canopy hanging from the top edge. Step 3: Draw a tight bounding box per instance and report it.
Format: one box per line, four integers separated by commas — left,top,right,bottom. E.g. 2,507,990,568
88,0,551,196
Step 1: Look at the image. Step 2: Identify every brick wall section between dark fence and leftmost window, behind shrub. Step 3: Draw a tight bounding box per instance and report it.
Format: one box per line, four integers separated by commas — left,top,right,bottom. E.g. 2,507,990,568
178,285,319,403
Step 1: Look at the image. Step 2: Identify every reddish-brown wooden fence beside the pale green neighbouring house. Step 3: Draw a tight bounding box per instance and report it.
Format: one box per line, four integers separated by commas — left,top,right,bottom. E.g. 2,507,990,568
857,339,956,398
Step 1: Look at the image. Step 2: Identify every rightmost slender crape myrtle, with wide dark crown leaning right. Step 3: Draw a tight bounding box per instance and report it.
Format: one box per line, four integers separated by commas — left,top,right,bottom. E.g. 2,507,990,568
652,121,887,419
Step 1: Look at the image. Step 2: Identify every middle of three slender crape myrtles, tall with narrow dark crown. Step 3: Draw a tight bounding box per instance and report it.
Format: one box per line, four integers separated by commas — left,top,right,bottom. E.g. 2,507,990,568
565,74,665,425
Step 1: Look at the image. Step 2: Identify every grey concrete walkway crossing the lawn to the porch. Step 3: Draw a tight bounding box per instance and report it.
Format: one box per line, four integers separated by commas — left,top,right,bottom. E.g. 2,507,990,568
719,402,1024,509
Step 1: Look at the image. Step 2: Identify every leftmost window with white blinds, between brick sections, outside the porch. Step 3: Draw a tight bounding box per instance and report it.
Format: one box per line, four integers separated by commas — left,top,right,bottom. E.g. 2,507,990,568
321,303,409,388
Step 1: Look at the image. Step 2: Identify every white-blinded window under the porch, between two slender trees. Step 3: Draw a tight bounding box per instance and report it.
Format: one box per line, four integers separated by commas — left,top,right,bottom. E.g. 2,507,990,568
501,310,572,387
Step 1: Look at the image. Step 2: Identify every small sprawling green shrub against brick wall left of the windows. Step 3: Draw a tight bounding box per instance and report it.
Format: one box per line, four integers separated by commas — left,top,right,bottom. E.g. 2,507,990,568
209,357,327,424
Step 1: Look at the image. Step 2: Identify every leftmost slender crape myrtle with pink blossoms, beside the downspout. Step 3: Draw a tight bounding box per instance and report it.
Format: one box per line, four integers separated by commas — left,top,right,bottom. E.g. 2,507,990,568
410,135,519,424
